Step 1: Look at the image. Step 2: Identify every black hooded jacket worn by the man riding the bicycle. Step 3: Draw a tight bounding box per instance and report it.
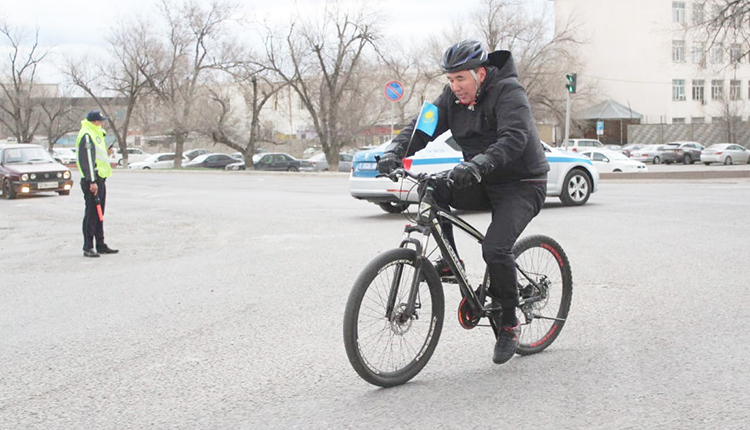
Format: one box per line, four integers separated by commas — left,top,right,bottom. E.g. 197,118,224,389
386,51,549,182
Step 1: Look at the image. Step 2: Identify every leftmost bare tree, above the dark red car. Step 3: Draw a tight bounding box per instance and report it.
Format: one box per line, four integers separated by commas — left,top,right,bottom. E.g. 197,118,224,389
0,20,49,143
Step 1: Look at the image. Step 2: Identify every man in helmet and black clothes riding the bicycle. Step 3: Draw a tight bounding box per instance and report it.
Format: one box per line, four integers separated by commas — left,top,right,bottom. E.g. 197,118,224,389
378,40,549,364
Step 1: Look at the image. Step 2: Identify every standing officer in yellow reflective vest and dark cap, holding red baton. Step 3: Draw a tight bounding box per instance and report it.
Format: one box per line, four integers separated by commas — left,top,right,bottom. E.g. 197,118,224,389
76,111,118,258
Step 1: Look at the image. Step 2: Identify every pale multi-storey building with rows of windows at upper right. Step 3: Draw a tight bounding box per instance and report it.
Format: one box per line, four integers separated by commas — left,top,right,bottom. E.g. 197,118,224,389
551,0,750,124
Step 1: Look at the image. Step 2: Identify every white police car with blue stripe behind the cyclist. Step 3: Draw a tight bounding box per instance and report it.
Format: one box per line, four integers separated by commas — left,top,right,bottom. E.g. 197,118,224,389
349,131,599,213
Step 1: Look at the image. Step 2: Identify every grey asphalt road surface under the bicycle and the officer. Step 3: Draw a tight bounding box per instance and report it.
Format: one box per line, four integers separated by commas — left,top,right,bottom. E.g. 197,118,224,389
0,170,750,430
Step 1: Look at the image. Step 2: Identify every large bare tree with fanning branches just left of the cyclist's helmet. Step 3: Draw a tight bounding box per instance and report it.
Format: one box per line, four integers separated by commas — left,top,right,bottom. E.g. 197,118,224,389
266,0,379,170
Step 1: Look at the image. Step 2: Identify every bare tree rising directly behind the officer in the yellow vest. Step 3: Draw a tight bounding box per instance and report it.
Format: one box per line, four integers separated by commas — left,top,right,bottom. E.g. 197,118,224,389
64,20,154,167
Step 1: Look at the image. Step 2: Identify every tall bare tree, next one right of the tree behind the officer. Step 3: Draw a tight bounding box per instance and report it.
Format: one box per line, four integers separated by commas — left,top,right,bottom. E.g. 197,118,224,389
142,0,237,167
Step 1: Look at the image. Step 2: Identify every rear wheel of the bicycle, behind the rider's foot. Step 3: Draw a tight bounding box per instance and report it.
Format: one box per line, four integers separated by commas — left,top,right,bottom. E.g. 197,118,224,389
513,235,573,355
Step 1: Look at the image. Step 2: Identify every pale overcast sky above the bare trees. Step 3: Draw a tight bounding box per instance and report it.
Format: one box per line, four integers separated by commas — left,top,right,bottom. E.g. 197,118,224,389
0,0,552,83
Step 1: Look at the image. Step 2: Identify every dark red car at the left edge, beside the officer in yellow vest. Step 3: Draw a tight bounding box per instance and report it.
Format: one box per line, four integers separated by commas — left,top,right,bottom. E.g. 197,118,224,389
0,143,73,199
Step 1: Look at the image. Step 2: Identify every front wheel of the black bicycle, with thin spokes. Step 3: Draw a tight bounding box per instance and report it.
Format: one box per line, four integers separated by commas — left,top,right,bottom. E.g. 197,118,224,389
344,248,445,387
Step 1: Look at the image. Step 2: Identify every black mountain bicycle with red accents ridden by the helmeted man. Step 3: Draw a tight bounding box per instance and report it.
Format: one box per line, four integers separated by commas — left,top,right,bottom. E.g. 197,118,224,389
344,169,573,387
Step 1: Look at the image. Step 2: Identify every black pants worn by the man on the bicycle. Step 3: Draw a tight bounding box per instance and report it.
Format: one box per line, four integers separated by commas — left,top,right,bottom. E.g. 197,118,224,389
434,176,547,309
